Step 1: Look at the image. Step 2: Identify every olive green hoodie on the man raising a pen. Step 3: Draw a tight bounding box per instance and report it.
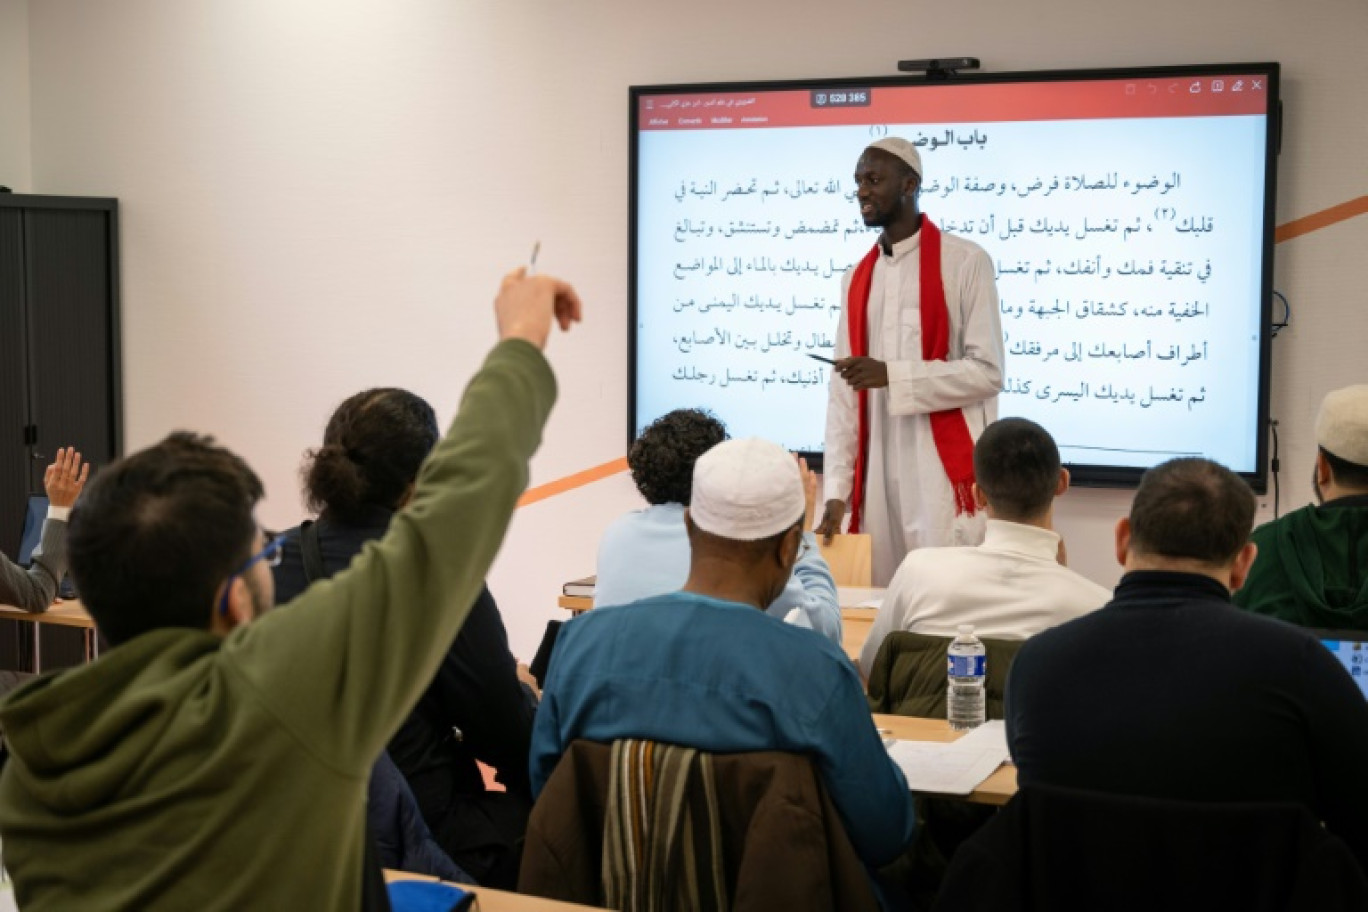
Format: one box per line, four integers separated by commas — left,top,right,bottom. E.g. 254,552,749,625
0,340,555,912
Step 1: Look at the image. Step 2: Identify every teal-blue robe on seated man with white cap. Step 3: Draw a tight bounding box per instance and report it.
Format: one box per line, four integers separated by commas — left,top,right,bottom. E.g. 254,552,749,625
531,592,917,866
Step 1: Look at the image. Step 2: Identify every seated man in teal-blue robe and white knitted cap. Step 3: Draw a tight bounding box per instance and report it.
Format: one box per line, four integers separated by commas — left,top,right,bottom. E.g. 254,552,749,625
531,438,915,866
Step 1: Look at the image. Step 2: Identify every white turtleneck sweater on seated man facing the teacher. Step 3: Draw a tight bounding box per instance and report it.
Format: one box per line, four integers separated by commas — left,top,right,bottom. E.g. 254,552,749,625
859,520,1111,678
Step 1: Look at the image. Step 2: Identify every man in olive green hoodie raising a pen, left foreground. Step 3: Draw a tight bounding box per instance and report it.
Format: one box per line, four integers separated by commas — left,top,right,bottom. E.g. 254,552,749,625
0,271,580,912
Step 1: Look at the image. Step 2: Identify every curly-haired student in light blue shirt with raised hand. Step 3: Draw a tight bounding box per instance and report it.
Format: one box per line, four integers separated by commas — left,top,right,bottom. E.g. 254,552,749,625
594,409,841,645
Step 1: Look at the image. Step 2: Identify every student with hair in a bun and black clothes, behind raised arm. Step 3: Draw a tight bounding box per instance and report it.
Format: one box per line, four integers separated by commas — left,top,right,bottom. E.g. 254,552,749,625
275,388,536,887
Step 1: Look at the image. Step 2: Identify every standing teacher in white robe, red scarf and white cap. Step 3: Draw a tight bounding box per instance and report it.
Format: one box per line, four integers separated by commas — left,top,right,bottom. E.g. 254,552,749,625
818,137,1003,585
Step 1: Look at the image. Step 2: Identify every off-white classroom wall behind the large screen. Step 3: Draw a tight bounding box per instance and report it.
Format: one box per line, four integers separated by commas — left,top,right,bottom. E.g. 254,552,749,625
21,0,1368,655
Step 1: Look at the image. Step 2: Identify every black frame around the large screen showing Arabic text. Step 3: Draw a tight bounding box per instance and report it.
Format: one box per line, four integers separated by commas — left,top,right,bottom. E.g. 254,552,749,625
627,62,1282,494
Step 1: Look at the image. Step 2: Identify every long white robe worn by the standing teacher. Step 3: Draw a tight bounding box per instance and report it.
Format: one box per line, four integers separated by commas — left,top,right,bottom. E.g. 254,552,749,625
822,231,1003,585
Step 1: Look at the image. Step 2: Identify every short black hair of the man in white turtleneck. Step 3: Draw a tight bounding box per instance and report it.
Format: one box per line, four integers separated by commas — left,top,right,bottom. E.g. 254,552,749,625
974,418,1060,522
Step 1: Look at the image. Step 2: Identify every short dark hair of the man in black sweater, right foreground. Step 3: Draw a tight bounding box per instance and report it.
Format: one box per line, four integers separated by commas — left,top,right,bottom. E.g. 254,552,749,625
1130,458,1257,566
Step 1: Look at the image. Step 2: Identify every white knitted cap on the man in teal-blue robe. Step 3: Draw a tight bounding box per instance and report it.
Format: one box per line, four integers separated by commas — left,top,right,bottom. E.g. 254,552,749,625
688,438,807,541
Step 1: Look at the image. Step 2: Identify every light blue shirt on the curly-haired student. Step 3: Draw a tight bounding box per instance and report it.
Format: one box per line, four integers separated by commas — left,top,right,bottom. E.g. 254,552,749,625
594,503,841,645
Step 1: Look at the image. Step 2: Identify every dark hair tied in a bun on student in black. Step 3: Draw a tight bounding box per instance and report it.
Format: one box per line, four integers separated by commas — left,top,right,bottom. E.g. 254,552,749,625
301,387,440,522
